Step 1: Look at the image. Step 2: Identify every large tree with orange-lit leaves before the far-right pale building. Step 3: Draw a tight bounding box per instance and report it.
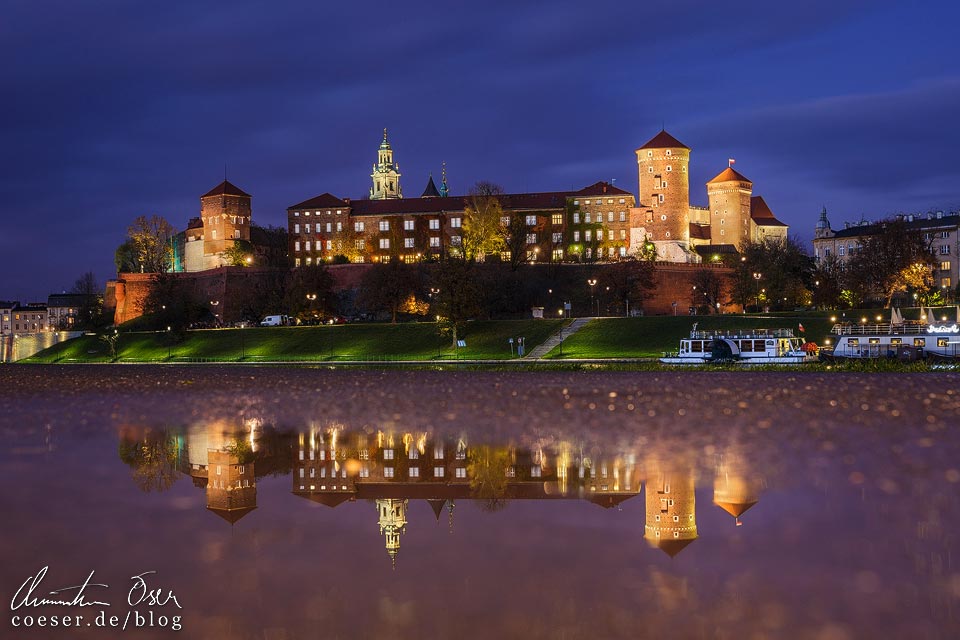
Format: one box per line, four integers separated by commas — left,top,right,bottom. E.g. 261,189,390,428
847,217,933,307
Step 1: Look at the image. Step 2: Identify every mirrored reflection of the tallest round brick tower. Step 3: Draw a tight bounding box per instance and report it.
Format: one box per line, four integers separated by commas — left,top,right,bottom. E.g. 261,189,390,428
643,465,697,558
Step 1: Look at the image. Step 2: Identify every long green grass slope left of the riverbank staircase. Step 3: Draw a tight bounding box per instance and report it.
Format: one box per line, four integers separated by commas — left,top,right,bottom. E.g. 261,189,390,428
25,319,562,362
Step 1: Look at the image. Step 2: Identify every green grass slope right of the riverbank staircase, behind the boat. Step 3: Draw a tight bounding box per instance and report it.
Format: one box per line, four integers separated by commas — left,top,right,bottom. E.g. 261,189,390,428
547,313,833,358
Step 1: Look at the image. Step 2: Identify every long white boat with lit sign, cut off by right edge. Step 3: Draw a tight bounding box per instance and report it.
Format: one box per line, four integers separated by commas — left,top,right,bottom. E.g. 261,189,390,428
823,309,960,361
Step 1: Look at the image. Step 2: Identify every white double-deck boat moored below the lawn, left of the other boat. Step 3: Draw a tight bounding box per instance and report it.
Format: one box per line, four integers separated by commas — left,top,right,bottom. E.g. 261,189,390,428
660,324,818,365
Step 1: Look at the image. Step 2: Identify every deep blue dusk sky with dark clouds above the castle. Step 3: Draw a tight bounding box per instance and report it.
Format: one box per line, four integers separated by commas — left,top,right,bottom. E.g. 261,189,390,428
0,0,960,302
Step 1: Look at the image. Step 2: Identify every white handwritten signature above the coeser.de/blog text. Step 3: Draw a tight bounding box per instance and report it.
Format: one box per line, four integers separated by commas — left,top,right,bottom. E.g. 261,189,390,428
10,567,183,611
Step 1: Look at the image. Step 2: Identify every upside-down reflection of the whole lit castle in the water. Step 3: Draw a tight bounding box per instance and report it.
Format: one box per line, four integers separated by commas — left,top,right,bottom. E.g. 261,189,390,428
119,419,763,566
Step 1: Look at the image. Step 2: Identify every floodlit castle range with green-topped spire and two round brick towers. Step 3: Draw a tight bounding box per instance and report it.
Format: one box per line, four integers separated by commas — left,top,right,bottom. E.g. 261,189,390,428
287,129,787,267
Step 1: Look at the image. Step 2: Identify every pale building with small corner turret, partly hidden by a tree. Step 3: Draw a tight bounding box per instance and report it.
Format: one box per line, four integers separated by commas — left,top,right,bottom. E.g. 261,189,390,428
813,207,960,289
